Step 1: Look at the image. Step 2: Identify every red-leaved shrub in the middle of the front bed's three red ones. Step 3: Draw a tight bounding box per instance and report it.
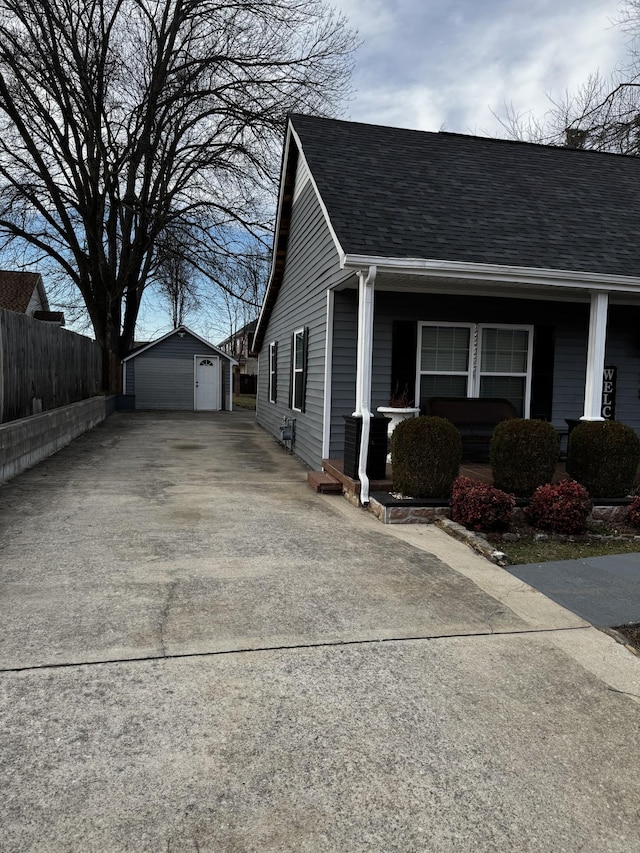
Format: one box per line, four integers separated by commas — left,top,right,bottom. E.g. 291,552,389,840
527,480,591,533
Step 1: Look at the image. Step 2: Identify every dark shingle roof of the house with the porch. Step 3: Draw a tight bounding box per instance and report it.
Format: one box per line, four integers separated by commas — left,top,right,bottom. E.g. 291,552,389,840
291,115,640,276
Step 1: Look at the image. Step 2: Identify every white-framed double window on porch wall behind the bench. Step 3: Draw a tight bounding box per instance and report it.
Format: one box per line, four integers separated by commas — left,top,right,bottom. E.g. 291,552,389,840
417,323,533,417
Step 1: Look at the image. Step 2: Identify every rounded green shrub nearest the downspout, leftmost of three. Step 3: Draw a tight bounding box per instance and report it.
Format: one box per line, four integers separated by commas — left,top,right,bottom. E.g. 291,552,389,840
391,415,462,498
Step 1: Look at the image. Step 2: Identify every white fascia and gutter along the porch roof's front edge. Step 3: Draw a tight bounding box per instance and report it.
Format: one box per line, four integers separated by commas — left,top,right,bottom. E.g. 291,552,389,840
341,255,640,293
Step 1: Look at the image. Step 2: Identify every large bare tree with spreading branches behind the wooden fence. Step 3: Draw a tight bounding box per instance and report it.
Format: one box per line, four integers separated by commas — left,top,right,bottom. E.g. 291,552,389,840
0,0,354,388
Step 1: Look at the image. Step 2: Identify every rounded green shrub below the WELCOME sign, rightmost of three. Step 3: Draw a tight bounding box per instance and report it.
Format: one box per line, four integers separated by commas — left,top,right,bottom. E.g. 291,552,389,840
567,421,640,498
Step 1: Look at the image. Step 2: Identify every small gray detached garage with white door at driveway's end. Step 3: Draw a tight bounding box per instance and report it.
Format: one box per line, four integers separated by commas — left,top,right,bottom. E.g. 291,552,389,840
122,326,237,412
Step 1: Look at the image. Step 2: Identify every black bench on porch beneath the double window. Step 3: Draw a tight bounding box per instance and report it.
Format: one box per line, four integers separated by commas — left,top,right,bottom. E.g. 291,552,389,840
425,397,518,458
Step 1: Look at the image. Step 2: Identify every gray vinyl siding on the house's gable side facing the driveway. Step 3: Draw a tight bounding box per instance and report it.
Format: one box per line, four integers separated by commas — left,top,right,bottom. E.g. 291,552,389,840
257,177,343,468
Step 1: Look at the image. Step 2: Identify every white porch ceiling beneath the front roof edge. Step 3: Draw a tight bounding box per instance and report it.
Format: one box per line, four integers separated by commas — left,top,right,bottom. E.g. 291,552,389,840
336,267,640,305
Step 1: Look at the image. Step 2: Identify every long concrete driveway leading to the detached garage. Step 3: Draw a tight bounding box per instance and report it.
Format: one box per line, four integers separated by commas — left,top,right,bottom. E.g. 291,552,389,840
0,412,640,853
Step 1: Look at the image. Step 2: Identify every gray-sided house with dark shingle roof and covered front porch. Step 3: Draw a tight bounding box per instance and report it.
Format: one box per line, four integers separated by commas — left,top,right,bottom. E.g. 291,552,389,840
254,115,640,500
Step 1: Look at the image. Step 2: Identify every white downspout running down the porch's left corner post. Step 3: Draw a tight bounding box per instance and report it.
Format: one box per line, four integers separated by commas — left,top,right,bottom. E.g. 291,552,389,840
354,266,377,506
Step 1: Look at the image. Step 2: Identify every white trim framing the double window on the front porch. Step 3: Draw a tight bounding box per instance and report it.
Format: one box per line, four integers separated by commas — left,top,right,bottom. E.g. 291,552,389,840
415,320,534,418
